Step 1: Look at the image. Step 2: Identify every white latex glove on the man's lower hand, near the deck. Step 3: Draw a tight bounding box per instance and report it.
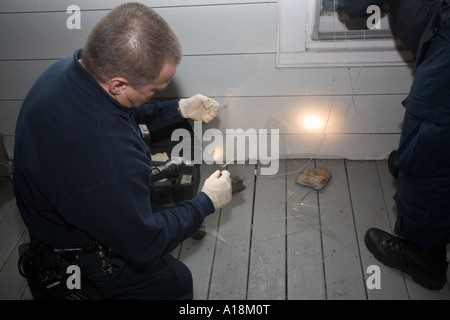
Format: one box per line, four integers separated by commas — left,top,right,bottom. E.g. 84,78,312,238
202,170,232,210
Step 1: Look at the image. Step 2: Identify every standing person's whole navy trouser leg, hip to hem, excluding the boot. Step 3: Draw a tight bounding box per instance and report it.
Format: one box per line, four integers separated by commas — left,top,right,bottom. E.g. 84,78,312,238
394,6,450,247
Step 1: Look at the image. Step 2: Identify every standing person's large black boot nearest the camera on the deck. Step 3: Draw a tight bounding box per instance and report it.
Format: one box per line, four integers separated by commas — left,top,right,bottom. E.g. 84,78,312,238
364,228,448,290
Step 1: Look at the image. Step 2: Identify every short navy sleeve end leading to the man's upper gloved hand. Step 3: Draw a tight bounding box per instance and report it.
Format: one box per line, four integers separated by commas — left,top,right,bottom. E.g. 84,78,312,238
134,100,183,131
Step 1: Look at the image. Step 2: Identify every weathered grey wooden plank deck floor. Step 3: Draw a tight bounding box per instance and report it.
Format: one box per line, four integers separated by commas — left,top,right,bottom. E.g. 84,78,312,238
0,160,450,300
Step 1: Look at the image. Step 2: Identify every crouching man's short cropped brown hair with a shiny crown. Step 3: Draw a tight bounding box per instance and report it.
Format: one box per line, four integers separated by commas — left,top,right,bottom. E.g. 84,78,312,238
81,2,182,88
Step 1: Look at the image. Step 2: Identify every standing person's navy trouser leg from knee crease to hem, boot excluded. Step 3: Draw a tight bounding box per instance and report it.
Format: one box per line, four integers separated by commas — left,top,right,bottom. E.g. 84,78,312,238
394,112,450,248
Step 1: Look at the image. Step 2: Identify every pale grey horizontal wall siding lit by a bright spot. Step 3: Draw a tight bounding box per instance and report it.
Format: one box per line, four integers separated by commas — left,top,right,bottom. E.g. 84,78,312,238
0,0,413,159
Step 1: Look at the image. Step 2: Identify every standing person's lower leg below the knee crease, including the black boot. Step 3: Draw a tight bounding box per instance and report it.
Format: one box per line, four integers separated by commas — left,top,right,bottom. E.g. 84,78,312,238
365,113,450,289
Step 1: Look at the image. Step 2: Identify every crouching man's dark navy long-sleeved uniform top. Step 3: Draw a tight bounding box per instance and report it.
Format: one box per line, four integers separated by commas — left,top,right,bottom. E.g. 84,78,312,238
14,50,214,263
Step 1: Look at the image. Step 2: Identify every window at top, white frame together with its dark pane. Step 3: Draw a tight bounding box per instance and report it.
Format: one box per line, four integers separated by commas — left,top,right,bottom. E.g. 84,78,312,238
277,0,414,68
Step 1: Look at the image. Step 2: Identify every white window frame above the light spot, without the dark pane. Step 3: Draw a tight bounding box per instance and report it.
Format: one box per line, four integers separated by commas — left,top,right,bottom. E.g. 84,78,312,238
276,0,413,68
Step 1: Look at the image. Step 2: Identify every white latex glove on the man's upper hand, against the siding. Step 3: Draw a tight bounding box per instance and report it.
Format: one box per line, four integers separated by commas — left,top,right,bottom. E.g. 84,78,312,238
178,94,220,123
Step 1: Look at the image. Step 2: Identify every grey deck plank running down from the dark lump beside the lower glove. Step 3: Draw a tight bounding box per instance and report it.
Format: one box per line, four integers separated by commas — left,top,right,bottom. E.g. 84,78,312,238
209,164,255,300
